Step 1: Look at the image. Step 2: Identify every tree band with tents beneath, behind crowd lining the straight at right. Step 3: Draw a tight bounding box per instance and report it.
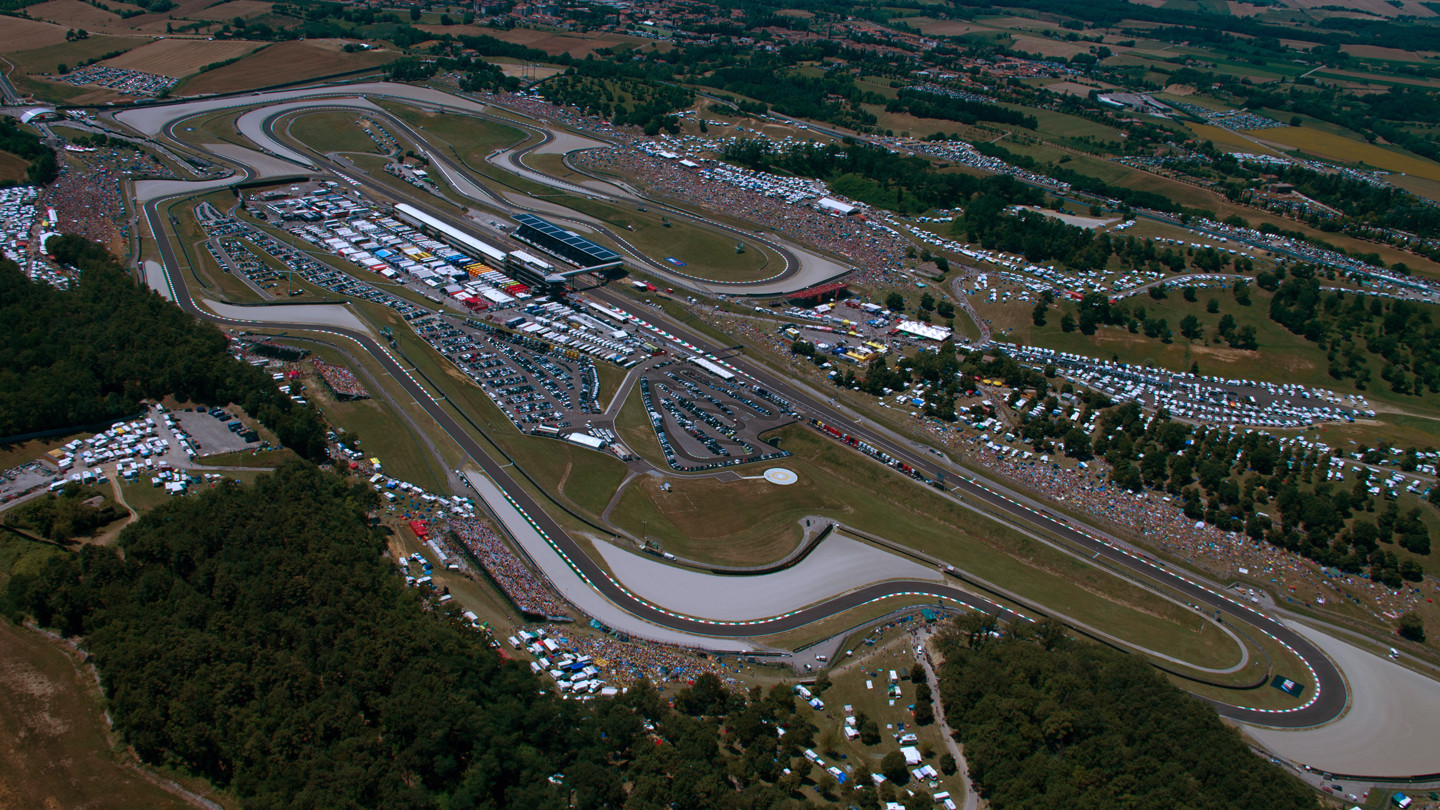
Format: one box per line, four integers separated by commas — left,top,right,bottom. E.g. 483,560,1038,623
898,343,1440,588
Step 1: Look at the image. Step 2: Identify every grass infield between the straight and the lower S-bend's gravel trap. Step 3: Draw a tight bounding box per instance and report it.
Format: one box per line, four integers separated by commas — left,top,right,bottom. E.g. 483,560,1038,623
612,397,1237,666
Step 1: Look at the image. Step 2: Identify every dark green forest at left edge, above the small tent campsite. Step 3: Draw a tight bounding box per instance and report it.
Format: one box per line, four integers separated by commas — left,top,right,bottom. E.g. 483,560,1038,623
0,235,325,460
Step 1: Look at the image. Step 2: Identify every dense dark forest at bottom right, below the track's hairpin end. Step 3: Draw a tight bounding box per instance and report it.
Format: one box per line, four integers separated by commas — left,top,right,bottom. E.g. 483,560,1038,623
940,615,1318,810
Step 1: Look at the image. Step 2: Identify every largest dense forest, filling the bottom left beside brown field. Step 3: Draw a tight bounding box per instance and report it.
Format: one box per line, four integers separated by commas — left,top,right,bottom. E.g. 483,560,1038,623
9,461,840,810
